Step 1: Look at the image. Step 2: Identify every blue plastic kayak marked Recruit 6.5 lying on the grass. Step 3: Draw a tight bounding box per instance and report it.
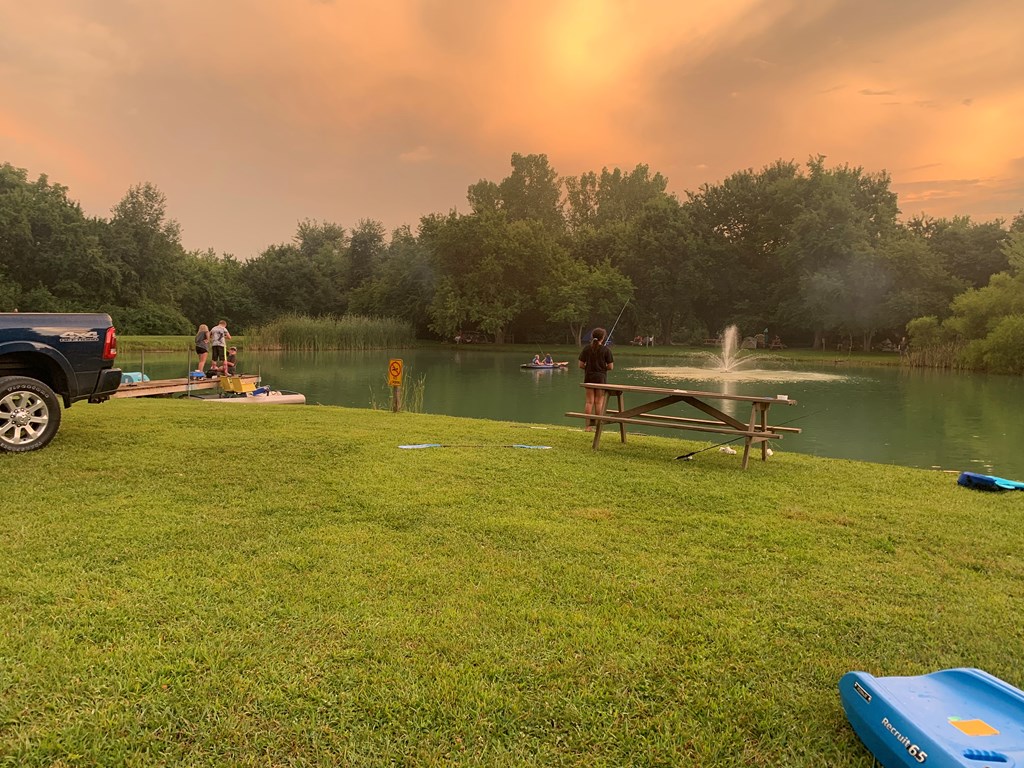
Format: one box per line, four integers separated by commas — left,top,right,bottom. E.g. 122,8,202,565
839,669,1024,768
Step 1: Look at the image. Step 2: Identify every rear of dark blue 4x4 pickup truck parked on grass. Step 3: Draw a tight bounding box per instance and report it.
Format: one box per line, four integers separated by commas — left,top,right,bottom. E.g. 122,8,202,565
0,312,121,453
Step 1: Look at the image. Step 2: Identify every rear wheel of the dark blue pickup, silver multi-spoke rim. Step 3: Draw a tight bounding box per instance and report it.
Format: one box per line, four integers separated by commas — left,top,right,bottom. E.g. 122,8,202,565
0,376,60,454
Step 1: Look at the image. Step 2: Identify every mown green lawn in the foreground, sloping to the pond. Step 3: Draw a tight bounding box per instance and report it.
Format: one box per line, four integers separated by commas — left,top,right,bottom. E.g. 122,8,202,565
0,400,1024,768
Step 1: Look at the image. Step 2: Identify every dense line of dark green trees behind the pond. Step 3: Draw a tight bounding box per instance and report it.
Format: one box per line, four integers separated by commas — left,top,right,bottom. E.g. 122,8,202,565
0,154,1024,367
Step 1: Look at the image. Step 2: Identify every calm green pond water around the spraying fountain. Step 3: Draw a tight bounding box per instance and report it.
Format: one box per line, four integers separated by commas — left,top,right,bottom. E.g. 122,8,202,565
125,348,1024,479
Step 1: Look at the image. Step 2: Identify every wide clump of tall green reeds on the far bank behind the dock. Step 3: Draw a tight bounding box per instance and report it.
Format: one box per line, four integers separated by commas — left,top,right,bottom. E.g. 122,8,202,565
246,314,416,352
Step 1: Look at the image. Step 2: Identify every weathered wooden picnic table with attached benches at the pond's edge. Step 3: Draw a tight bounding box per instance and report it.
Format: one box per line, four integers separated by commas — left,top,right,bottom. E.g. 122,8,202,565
565,384,800,469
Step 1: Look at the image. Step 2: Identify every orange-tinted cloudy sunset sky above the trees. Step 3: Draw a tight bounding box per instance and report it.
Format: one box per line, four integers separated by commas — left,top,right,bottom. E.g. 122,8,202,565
0,0,1024,258
